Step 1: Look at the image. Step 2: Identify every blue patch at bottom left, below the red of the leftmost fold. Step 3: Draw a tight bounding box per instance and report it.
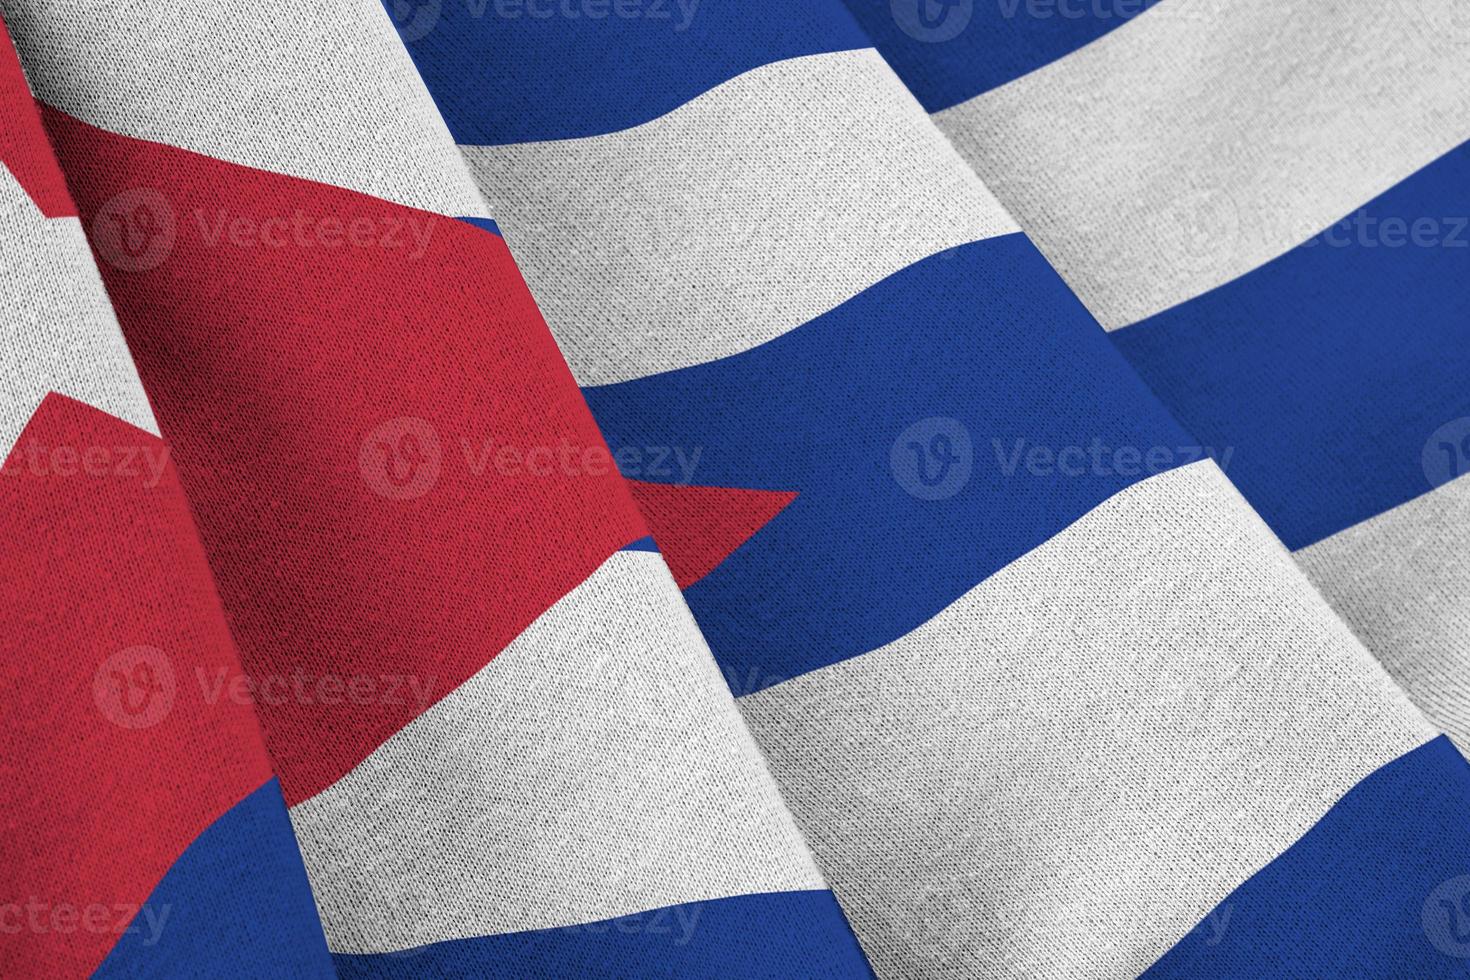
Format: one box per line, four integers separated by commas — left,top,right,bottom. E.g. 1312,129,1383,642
94,779,335,977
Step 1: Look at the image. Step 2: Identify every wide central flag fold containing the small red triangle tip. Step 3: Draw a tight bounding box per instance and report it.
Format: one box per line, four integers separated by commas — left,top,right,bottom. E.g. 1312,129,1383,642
388,3,1466,976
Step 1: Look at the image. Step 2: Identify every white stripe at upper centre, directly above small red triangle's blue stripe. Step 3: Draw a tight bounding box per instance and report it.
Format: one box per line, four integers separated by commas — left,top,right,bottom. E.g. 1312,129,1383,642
462,50,1016,385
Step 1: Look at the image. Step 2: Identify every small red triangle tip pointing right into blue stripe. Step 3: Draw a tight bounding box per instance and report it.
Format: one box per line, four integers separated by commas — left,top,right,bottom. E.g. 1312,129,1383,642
628,480,797,589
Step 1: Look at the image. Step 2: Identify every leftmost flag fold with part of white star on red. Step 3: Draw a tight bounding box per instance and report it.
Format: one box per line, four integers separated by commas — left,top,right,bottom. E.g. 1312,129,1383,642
0,17,332,977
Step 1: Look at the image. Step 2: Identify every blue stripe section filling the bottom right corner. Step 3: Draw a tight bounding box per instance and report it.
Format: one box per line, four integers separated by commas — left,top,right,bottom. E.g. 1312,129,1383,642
1144,736,1470,980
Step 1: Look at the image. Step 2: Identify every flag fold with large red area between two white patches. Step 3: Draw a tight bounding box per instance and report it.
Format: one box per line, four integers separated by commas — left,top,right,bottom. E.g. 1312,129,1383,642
7,6,869,977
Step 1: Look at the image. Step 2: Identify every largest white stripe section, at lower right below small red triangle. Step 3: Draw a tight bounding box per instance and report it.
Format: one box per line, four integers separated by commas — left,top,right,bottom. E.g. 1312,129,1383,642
739,463,1433,977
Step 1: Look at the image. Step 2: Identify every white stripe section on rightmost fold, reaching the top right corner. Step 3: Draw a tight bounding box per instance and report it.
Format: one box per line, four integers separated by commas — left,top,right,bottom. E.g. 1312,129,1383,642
935,0,1470,329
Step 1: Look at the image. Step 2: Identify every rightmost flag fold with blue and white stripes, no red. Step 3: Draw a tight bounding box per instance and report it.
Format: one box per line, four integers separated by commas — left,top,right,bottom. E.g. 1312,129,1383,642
851,0,1470,746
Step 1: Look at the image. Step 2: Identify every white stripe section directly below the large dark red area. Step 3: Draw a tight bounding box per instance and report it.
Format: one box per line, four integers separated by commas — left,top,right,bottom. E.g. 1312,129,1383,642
291,552,826,952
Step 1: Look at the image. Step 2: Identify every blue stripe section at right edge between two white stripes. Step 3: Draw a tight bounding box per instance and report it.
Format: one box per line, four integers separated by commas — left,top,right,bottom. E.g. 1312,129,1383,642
1113,144,1470,550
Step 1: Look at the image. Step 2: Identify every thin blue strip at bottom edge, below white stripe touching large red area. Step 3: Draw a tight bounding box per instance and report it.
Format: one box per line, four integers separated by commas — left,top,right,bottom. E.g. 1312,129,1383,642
337,892,873,980
